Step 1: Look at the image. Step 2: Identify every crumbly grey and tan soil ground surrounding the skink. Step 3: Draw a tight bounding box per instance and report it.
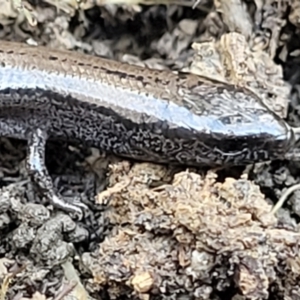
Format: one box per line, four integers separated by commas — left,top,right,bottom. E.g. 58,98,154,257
0,0,300,299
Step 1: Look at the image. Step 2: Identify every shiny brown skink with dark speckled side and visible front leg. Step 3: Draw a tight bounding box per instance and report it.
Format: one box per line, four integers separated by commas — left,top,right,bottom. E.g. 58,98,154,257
0,41,296,215
